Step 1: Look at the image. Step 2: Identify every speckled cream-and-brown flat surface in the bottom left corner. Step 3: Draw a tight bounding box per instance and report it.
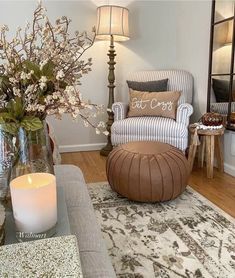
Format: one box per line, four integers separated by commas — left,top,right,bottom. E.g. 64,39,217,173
0,235,83,278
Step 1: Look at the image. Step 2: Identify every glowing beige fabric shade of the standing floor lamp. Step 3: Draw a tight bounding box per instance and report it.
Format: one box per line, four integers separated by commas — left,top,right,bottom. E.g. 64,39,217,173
96,5,129,41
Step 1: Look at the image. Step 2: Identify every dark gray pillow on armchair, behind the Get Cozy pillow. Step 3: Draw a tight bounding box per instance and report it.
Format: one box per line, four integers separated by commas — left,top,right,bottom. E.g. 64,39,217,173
126,79,168,92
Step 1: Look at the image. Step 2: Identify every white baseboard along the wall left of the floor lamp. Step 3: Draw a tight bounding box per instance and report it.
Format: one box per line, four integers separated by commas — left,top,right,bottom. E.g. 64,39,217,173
59,143,106,153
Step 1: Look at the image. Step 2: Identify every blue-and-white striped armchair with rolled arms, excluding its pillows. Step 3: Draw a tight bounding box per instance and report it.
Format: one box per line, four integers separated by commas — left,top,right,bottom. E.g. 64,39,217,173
111,70,193,151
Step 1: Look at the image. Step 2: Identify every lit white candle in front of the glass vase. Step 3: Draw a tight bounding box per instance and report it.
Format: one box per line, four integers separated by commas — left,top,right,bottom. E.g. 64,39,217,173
10,173,57,234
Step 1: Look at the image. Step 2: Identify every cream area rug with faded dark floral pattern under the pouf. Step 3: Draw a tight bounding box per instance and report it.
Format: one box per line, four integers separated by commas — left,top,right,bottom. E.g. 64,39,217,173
88,182,235,278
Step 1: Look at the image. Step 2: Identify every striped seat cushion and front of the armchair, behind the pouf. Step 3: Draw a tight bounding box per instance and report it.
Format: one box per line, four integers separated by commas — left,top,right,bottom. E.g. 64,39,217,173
111,117,188,151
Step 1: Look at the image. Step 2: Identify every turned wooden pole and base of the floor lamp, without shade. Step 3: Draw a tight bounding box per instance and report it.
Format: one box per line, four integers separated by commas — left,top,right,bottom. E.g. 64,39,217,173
100,35,116,156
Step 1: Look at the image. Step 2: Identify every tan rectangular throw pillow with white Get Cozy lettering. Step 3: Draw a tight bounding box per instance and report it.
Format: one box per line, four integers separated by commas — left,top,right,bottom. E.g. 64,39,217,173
128,89,181,119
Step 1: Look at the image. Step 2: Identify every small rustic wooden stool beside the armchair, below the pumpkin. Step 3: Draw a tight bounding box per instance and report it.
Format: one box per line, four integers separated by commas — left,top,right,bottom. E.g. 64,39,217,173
188,125,225,178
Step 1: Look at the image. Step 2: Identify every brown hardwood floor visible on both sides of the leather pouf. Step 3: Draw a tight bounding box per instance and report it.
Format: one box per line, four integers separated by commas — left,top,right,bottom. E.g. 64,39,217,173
62,151,235,217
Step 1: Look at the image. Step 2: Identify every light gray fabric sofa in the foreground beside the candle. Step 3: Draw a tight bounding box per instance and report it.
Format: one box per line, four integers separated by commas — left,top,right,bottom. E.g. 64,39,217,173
55,165,116,278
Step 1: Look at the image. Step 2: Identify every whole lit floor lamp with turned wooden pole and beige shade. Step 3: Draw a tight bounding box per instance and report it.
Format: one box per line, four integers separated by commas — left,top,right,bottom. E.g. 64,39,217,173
96,5,129,156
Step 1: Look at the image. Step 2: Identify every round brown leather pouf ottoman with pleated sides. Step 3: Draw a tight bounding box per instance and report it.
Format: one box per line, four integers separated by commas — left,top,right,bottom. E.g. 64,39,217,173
106,141,190,202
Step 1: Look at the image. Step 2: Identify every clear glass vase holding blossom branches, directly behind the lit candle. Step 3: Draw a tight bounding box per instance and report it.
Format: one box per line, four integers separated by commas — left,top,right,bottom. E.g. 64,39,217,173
11,121,54,179
